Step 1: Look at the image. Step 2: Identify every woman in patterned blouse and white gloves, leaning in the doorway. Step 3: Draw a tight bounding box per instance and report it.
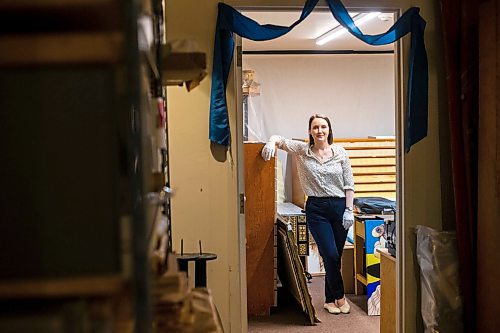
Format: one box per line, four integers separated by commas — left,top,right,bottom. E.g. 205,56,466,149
262,114,354,314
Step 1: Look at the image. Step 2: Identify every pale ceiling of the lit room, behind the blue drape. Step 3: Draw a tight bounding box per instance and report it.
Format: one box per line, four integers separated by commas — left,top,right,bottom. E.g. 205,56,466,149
242,10,394,51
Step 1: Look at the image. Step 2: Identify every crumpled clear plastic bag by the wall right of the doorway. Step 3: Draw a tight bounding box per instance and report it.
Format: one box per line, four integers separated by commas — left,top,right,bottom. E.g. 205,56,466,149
415,225,464,333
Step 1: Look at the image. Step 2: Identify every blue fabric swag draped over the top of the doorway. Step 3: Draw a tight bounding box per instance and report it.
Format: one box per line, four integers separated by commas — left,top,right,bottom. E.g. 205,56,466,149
209,0,428,152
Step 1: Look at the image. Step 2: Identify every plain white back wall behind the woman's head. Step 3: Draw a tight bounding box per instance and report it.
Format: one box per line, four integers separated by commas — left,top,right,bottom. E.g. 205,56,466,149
243,52,395,141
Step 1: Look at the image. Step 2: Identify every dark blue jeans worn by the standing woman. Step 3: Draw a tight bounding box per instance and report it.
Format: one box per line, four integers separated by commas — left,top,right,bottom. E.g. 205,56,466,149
306,197,347,303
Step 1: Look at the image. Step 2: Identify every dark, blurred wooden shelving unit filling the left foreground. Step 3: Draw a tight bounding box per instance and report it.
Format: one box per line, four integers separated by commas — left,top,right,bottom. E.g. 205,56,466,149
0,0,171,332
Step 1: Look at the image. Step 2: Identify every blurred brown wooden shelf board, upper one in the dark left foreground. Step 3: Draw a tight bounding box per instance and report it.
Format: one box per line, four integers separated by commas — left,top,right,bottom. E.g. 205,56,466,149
0,33,123,67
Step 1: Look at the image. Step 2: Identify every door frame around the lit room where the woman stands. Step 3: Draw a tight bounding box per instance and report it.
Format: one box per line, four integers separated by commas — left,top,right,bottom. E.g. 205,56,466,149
230,0,410,332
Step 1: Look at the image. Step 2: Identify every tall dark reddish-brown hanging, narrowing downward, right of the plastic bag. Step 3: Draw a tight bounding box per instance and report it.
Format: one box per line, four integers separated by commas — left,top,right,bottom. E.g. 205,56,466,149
440,0,481,332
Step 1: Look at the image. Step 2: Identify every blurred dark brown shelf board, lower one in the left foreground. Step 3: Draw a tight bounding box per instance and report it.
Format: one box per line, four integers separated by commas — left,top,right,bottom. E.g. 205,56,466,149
0,276,125,299
